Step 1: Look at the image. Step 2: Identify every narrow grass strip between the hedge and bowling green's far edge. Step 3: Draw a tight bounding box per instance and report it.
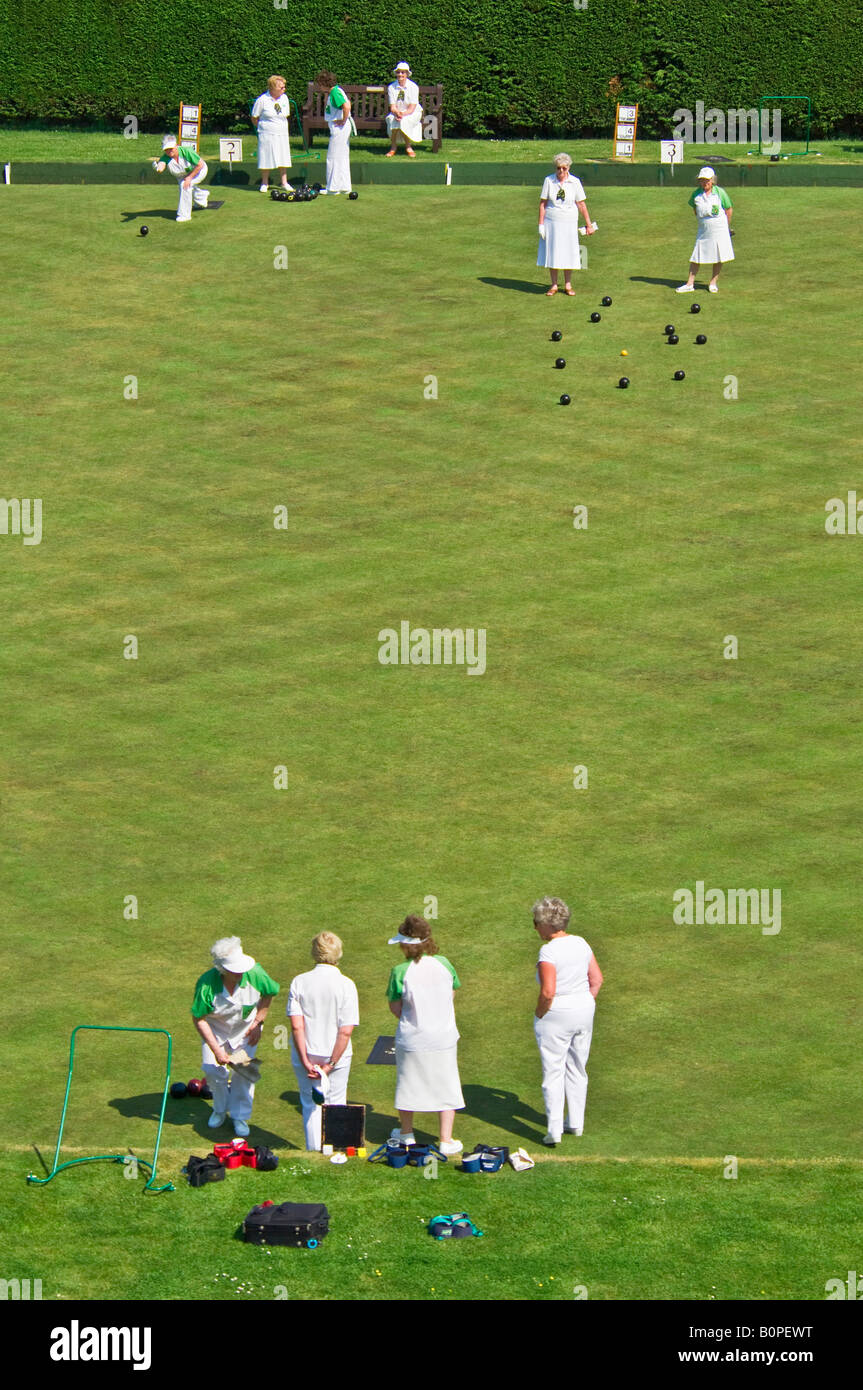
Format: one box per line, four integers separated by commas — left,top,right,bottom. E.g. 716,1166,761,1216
0,125,863,164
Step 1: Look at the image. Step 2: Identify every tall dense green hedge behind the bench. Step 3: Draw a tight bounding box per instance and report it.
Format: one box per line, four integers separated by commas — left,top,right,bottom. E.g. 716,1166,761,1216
0,0,863,136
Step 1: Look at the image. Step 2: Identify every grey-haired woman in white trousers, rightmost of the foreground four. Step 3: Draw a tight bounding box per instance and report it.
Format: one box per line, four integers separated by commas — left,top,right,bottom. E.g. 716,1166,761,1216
534,898,602,1145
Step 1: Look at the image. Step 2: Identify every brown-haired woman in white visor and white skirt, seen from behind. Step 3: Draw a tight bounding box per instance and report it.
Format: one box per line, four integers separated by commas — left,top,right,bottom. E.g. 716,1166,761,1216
386,916,464,1154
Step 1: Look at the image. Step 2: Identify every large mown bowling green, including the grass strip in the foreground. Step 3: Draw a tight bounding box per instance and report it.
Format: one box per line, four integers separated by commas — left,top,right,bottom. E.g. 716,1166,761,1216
0,179,863,1300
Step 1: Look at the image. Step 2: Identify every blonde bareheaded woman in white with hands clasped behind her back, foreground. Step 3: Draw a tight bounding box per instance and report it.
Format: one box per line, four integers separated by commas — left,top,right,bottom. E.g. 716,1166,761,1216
288,931,360,1150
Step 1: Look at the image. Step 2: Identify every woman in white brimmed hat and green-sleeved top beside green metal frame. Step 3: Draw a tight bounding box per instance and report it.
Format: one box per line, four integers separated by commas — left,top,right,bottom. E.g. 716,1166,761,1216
192,937,279,1138
